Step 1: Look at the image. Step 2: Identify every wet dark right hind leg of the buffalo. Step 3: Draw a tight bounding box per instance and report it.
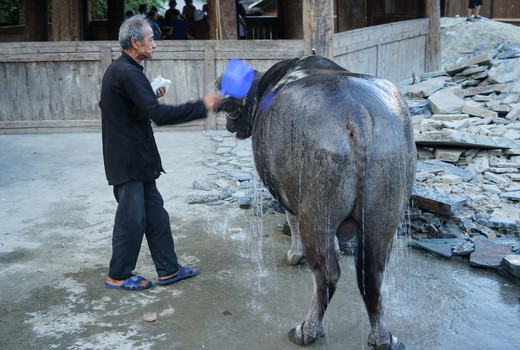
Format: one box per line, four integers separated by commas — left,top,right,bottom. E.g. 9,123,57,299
356,219,406,350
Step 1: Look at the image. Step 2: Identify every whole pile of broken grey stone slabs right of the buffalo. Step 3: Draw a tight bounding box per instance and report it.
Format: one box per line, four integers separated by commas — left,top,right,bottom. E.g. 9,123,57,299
399,19,520,284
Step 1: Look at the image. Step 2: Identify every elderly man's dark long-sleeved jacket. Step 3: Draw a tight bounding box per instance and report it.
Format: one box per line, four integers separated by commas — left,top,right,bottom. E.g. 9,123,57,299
99,52,207,185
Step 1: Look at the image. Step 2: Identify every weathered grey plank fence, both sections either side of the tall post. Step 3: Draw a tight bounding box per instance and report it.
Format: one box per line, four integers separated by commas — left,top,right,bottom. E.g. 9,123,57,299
0,19,428,133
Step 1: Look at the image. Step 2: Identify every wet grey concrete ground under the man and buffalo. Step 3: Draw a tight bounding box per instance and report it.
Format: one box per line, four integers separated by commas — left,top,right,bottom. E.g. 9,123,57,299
0,131,520,350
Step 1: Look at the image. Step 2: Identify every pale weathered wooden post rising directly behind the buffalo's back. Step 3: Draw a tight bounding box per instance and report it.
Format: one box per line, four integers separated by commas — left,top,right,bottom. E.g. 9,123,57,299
302,0,334,59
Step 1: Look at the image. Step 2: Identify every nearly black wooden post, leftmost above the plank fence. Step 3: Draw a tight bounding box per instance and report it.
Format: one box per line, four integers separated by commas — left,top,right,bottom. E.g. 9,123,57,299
23,0,49,41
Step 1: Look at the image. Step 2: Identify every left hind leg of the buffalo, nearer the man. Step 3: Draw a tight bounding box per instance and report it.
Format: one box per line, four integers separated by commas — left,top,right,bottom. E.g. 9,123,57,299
288,220,340,345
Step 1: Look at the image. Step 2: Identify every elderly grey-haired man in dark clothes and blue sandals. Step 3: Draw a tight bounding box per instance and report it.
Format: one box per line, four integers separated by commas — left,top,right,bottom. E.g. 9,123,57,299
99,16,221,290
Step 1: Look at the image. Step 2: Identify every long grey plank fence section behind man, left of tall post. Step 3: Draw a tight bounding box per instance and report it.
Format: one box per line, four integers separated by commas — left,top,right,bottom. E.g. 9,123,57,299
0,40,303,133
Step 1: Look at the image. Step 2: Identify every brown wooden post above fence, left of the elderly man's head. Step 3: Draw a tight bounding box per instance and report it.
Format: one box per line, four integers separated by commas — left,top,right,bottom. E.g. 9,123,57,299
52,0,81,41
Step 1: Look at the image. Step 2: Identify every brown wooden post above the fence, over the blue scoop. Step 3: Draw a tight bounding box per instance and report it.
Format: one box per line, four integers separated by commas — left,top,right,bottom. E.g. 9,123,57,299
208,0,238,40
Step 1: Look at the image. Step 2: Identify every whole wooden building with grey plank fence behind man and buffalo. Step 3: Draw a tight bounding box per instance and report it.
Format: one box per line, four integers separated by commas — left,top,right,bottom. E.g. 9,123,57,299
0,0,440,132
